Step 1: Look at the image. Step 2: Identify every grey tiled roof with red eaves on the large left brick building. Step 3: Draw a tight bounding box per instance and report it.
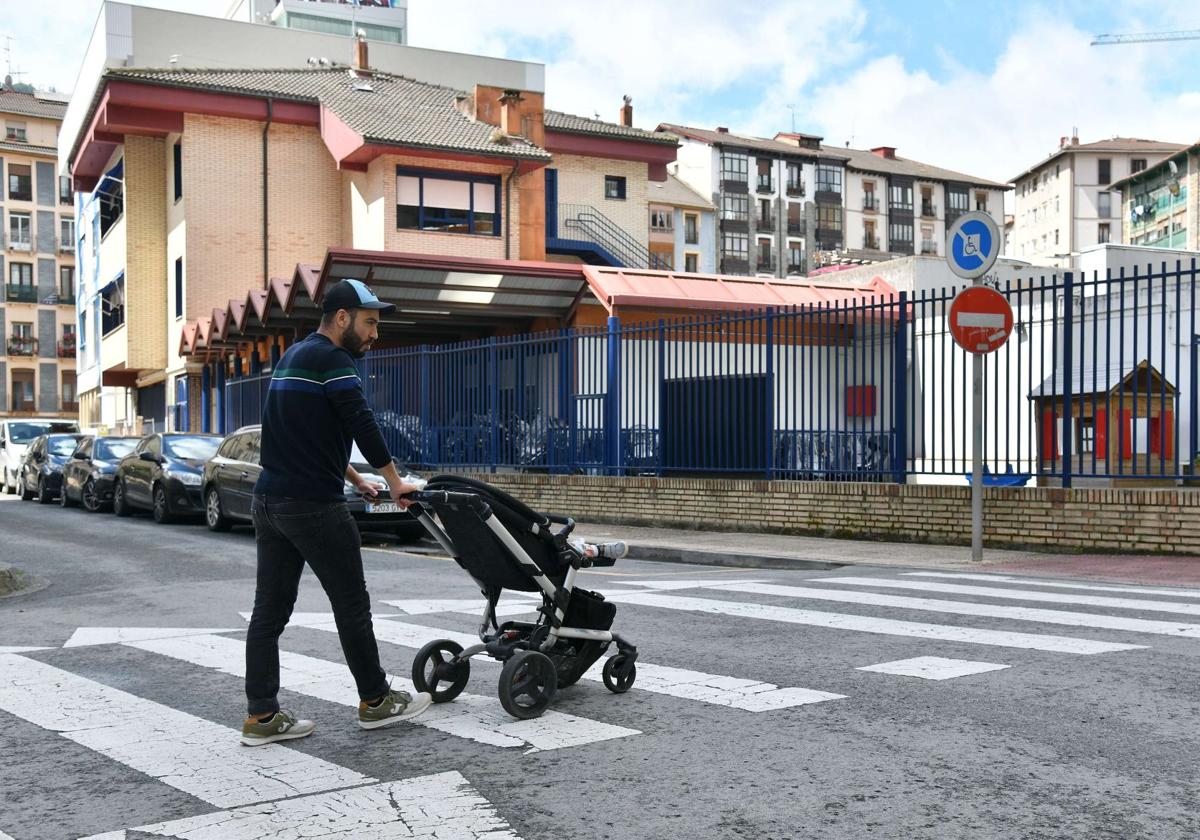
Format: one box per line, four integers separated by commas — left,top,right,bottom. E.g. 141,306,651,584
108,66,550,161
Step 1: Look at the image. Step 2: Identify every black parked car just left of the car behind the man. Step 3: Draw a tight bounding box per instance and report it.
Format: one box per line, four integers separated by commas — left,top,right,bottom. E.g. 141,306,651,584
113,432,221,523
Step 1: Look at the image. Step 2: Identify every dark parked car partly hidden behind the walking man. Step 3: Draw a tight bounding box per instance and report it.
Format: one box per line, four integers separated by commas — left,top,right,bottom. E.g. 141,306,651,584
203,426,426,542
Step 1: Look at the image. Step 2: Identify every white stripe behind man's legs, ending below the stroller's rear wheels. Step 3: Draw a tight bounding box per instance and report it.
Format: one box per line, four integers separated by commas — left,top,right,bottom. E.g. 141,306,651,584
139,622,641,751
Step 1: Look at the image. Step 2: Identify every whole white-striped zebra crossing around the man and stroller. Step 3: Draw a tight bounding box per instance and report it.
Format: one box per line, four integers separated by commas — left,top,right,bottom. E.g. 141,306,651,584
0,570,1200,840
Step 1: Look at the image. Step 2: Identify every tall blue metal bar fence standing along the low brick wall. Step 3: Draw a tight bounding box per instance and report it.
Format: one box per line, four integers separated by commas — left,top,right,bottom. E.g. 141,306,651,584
224,263,1200,485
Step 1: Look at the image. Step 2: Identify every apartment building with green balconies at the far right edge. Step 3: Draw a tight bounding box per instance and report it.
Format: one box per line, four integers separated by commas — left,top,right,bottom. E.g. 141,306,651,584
1112,143,1200,251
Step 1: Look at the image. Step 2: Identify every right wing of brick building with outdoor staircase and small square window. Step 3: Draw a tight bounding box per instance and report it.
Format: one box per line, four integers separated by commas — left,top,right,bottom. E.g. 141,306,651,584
545,97,678,269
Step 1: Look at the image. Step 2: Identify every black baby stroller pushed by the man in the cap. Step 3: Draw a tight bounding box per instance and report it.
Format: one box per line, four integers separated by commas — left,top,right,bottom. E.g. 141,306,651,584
409,475,637,719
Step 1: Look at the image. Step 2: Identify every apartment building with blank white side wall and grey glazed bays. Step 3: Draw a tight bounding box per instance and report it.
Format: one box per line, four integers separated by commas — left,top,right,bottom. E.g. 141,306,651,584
659,124,848,277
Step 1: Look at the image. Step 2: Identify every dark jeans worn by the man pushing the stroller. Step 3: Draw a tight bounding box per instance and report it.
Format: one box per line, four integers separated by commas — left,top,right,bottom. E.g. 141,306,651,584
246,494,388,715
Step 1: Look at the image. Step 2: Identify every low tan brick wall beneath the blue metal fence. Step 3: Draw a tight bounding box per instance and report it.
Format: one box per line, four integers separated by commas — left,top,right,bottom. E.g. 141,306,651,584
458,474,1200,554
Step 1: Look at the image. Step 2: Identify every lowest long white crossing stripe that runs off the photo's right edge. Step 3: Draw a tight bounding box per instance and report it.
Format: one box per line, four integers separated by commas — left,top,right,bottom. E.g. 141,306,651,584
710,583,1200,638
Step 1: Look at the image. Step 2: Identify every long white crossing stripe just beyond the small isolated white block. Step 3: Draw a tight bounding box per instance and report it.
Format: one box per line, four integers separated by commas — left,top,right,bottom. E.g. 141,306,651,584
600,593,1146,655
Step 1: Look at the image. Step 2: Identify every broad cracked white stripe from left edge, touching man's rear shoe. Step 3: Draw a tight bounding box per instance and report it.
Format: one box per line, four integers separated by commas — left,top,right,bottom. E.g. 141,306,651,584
0,654,377,808
